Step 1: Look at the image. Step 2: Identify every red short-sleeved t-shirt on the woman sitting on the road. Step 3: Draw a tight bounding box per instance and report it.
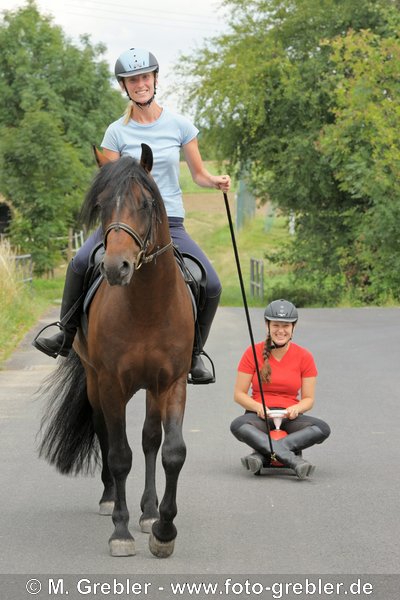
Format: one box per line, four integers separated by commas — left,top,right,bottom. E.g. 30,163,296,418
238,342,318,408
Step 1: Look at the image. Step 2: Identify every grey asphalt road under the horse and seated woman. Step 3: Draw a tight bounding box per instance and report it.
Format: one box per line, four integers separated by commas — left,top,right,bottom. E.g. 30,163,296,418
0,308,400,600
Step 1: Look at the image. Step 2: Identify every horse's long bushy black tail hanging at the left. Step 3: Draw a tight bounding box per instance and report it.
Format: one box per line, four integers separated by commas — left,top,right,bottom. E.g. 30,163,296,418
38,350,99,475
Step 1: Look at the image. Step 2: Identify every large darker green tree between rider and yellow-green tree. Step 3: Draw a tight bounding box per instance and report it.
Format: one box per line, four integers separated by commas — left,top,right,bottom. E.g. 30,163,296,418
180,0,399,302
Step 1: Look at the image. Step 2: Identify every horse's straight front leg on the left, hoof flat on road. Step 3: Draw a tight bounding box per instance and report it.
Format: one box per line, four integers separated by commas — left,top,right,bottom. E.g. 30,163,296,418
100,388,135,556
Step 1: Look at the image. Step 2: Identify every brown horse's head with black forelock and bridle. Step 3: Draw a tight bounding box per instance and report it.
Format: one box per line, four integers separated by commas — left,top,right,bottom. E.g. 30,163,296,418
83,144,170,285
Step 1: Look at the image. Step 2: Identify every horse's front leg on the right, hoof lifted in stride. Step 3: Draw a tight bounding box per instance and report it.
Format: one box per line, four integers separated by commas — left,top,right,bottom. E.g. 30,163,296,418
149,376,186,558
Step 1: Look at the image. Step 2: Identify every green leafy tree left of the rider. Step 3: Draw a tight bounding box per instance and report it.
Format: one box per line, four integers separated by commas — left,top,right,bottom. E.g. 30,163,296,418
0,0,124,273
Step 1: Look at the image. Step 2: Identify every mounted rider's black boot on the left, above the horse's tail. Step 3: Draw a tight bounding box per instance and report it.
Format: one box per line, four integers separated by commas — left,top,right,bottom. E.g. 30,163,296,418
32,263,85,358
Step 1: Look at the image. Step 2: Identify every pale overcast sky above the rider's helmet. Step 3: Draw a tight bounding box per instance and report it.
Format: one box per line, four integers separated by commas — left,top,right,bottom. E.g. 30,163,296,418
0,0,227,109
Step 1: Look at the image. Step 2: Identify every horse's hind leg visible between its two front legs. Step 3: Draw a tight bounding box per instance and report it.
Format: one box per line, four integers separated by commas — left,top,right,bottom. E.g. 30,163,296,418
139,392,162,533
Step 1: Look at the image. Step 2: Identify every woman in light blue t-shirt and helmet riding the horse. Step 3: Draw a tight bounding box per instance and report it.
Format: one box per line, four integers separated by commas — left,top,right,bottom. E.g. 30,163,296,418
34,48,230,384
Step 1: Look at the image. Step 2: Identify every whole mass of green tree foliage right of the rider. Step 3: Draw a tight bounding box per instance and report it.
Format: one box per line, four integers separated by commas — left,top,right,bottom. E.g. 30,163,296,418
178,0,400,302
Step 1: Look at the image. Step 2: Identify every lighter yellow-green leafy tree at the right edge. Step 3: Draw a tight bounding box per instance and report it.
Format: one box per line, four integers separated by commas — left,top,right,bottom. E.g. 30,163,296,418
320,30,400,299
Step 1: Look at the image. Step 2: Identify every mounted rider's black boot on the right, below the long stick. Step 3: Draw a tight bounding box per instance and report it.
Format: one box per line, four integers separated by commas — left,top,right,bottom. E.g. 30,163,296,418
188,292,221,385
